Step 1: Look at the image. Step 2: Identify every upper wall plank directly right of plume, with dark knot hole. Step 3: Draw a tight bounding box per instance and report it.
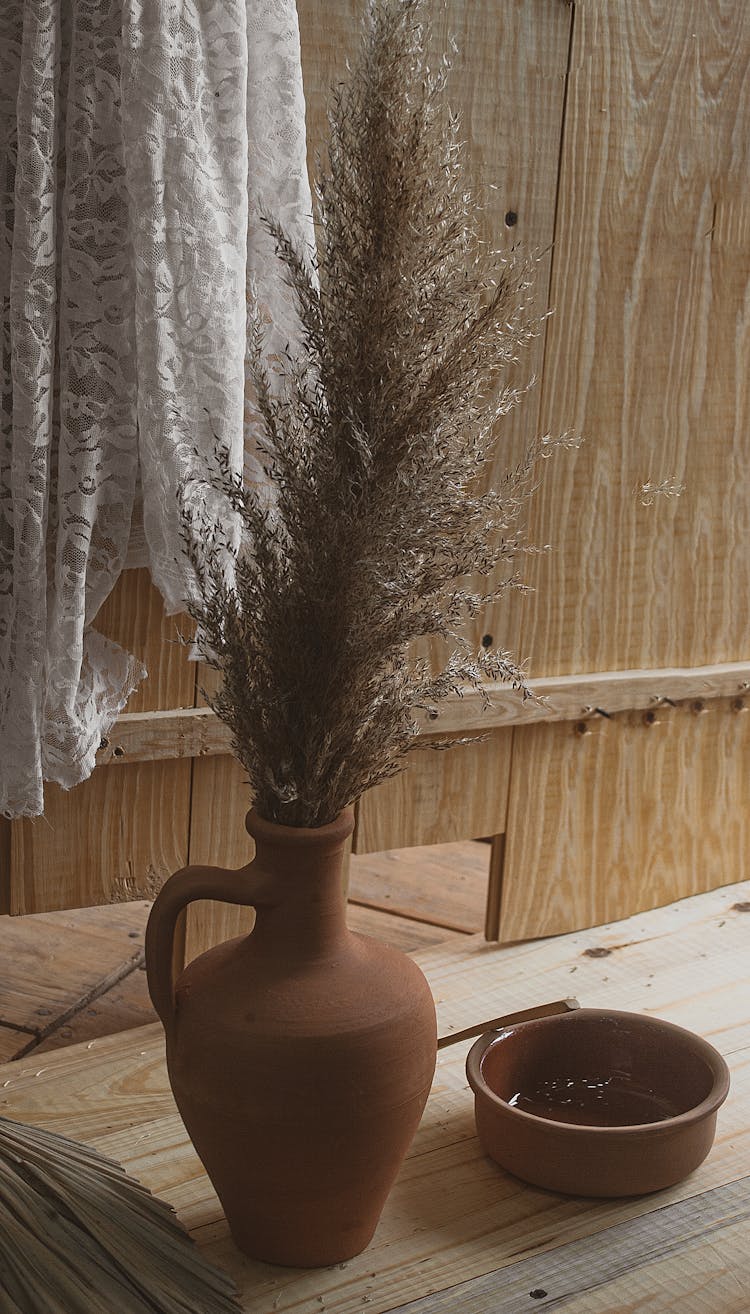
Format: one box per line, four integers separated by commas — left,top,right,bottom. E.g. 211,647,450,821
415,0,571,662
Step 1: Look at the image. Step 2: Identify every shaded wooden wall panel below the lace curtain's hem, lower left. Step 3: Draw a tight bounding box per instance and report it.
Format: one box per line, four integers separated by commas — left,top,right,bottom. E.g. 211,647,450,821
9,570,196,913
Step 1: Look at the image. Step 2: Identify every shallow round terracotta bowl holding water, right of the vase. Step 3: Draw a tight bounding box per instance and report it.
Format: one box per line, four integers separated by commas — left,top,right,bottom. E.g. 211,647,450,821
466,1008,729,1196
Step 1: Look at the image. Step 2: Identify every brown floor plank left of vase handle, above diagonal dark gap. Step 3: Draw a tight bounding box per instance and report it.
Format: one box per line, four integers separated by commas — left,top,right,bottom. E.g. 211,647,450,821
0,903,148,1035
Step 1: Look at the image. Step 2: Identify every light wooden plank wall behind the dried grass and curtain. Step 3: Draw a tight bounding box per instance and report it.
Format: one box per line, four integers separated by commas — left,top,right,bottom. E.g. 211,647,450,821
0,0,750,949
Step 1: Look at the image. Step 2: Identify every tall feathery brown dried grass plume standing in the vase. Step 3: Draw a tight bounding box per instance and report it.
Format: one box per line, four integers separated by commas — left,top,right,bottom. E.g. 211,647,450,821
185,0,575,827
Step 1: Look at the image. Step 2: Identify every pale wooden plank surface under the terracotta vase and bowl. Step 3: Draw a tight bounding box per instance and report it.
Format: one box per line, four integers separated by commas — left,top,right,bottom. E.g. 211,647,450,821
0,882,750,1314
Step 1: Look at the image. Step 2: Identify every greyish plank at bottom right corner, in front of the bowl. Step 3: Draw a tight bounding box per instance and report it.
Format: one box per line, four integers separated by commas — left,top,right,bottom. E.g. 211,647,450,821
391,1177,750,1314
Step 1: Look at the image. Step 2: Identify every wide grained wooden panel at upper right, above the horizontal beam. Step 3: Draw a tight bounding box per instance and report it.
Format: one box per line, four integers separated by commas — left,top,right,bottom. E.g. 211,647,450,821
523,0,750,678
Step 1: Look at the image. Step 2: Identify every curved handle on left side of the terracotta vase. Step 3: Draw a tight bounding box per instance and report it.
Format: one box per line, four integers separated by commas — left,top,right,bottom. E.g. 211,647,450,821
146,859,275,1030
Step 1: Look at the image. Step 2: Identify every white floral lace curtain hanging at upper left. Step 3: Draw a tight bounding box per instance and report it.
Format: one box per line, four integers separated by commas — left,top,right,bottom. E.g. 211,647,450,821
0,0,313,816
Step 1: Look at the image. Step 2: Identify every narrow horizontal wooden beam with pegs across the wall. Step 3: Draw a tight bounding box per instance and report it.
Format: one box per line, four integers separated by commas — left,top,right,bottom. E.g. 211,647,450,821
97,662,750,763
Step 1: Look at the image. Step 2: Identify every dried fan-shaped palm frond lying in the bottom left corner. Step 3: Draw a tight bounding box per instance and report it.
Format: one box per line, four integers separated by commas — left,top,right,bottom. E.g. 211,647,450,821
0,1118,240,1314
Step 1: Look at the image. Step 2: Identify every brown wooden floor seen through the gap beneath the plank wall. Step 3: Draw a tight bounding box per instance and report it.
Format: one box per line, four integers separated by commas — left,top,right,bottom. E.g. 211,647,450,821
0,841,490,1062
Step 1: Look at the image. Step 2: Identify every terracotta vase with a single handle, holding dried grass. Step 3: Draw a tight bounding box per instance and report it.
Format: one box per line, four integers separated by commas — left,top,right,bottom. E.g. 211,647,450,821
146,812,436,1267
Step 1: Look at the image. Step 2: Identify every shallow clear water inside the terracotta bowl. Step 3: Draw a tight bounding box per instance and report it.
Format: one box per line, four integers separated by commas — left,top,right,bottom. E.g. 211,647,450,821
508,1072,683,1127
